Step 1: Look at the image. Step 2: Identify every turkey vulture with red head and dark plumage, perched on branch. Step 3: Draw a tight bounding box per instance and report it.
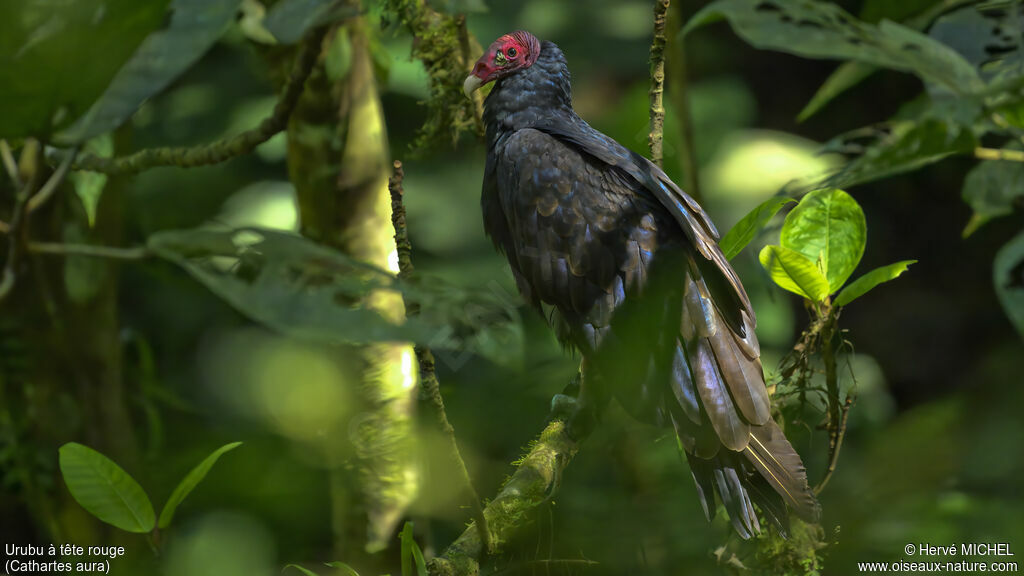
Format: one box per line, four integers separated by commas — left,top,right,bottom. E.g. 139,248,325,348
464,31,819,538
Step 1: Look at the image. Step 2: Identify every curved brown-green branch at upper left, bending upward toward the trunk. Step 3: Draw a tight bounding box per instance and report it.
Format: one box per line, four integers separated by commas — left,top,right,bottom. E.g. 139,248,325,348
73,27,327,174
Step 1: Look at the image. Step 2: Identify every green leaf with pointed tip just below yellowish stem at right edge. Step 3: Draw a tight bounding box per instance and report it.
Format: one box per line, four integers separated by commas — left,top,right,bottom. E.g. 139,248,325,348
962,153,1024,237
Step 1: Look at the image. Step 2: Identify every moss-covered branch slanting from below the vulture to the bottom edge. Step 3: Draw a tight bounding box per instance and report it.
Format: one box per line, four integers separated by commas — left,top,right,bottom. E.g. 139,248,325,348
427,420,580,576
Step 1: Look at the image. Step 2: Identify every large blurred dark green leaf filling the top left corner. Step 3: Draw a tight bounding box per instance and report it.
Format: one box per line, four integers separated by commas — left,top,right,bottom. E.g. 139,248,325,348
0,0,167,138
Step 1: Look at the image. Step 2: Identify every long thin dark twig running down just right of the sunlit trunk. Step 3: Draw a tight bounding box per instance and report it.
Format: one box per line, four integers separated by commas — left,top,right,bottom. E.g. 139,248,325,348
388,160,490,551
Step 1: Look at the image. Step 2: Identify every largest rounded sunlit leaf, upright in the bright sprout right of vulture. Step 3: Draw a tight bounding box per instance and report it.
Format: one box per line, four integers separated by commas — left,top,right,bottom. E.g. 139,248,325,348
780,189,867,294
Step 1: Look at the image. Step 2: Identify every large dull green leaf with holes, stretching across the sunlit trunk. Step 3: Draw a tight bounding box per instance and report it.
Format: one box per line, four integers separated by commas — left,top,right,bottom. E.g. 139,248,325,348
147,229,522,366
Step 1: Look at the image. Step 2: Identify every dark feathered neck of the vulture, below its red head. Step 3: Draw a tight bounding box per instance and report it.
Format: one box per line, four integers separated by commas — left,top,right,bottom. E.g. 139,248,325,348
483,42,575,147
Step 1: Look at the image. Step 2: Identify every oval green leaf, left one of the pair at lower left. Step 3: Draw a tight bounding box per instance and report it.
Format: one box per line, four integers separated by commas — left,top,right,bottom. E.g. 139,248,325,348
59,442,156,534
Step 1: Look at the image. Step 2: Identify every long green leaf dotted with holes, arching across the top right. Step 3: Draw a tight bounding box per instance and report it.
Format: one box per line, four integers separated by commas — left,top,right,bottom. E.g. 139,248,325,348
683,0,984,94
